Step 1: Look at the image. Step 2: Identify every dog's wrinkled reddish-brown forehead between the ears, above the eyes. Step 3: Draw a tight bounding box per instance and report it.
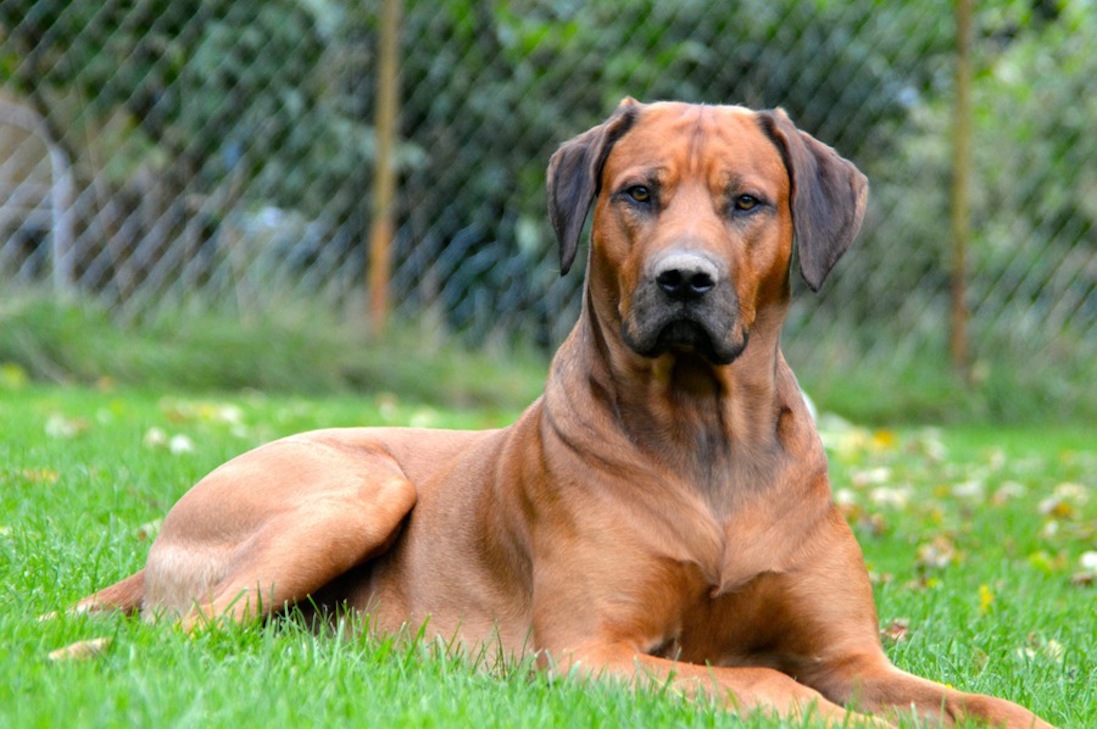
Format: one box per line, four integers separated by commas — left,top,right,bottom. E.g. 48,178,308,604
602,102,788,193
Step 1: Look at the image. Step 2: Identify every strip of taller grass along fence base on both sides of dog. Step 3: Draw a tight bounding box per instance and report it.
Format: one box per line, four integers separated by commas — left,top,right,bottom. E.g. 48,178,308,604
0,288,1097,424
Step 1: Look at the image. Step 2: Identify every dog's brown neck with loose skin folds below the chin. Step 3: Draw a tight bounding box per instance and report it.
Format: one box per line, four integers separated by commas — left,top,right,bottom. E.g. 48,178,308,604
545,289,802,480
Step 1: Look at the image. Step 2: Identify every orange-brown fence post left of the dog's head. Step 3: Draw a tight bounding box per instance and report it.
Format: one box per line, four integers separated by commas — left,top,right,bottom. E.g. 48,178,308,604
367,0,402,334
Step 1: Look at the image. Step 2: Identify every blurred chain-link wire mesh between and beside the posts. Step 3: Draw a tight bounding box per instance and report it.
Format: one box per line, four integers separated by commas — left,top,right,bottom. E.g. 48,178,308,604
0,0,1097,399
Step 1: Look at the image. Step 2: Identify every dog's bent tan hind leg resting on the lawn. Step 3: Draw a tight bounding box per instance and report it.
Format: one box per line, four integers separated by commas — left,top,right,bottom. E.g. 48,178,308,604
133,435,416,629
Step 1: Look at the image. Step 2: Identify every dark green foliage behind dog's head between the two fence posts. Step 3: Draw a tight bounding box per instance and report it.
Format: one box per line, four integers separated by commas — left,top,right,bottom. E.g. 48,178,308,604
402,0,950,344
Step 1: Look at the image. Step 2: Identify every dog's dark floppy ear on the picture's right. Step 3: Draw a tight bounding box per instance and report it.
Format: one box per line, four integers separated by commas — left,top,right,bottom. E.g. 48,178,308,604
759,109,869,292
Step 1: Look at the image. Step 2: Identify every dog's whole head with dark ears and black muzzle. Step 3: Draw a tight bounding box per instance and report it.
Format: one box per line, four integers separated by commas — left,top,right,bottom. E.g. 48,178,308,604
549,99,868,365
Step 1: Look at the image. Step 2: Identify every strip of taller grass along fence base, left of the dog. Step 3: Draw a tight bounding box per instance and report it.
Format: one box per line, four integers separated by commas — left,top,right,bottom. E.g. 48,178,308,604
0,294,544,408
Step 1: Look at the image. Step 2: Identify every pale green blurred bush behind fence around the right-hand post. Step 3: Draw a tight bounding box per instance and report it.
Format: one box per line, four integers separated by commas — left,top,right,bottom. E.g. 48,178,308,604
790,2,1097,392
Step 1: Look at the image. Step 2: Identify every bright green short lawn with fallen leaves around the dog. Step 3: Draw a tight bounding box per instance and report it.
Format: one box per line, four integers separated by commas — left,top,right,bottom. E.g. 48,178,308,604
0,384,1097,727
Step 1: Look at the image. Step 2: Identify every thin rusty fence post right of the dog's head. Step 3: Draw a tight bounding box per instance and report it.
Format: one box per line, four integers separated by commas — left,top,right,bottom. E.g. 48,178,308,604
949,0,972,383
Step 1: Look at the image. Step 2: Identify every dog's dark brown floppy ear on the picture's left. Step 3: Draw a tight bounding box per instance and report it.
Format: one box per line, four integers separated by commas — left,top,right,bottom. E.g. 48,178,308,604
547,98,641,275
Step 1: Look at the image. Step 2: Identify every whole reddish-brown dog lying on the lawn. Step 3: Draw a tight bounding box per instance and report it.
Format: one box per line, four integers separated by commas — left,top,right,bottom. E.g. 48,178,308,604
79,100,1048,728
